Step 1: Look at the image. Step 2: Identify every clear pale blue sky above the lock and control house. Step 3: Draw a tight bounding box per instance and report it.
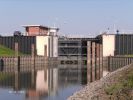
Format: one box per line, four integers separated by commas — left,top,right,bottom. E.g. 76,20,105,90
0,0,133,36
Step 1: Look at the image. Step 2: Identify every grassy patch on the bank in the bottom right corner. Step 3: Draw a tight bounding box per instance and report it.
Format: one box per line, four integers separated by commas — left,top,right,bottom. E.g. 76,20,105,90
104,65,133,100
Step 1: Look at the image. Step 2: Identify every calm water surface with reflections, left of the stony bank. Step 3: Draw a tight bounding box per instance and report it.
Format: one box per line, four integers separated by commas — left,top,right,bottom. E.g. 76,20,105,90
0,66,86,100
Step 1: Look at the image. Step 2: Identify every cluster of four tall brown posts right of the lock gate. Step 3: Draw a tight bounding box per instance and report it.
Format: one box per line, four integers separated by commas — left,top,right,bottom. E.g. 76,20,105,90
87,41,103,82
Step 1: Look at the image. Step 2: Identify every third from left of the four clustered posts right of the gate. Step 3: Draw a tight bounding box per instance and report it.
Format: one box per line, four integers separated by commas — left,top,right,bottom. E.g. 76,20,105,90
96,43,100,79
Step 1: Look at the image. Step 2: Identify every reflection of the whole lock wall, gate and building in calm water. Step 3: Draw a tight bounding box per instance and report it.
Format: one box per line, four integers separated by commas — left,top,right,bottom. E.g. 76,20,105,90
0,63,85,100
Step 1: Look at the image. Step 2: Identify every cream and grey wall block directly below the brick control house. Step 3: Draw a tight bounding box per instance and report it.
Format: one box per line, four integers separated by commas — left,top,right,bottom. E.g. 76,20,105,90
36,36,58,57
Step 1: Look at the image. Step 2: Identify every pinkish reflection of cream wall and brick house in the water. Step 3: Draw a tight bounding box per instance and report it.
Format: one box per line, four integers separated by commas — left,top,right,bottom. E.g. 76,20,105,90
26,68,58,100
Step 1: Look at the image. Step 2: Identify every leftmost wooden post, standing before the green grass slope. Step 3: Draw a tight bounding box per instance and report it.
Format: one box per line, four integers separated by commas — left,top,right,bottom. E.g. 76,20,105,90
14,42,20,72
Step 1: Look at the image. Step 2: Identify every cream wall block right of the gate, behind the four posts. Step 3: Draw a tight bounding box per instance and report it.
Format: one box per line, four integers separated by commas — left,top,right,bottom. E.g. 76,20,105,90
102,34,115,57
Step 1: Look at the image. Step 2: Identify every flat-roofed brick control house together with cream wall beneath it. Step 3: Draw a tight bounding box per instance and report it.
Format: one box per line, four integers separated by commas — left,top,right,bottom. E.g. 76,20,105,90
24,25,59,57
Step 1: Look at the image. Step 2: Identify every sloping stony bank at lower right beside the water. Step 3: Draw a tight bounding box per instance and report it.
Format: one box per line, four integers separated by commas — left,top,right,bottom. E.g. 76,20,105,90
68,64,133,100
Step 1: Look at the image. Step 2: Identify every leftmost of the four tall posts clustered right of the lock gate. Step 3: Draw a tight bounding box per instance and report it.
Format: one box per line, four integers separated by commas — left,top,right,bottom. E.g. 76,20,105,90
87,41,92,83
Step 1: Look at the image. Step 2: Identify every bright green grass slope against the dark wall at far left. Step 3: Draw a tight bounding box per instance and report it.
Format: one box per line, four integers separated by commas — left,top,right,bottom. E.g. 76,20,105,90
0,45,23,56
